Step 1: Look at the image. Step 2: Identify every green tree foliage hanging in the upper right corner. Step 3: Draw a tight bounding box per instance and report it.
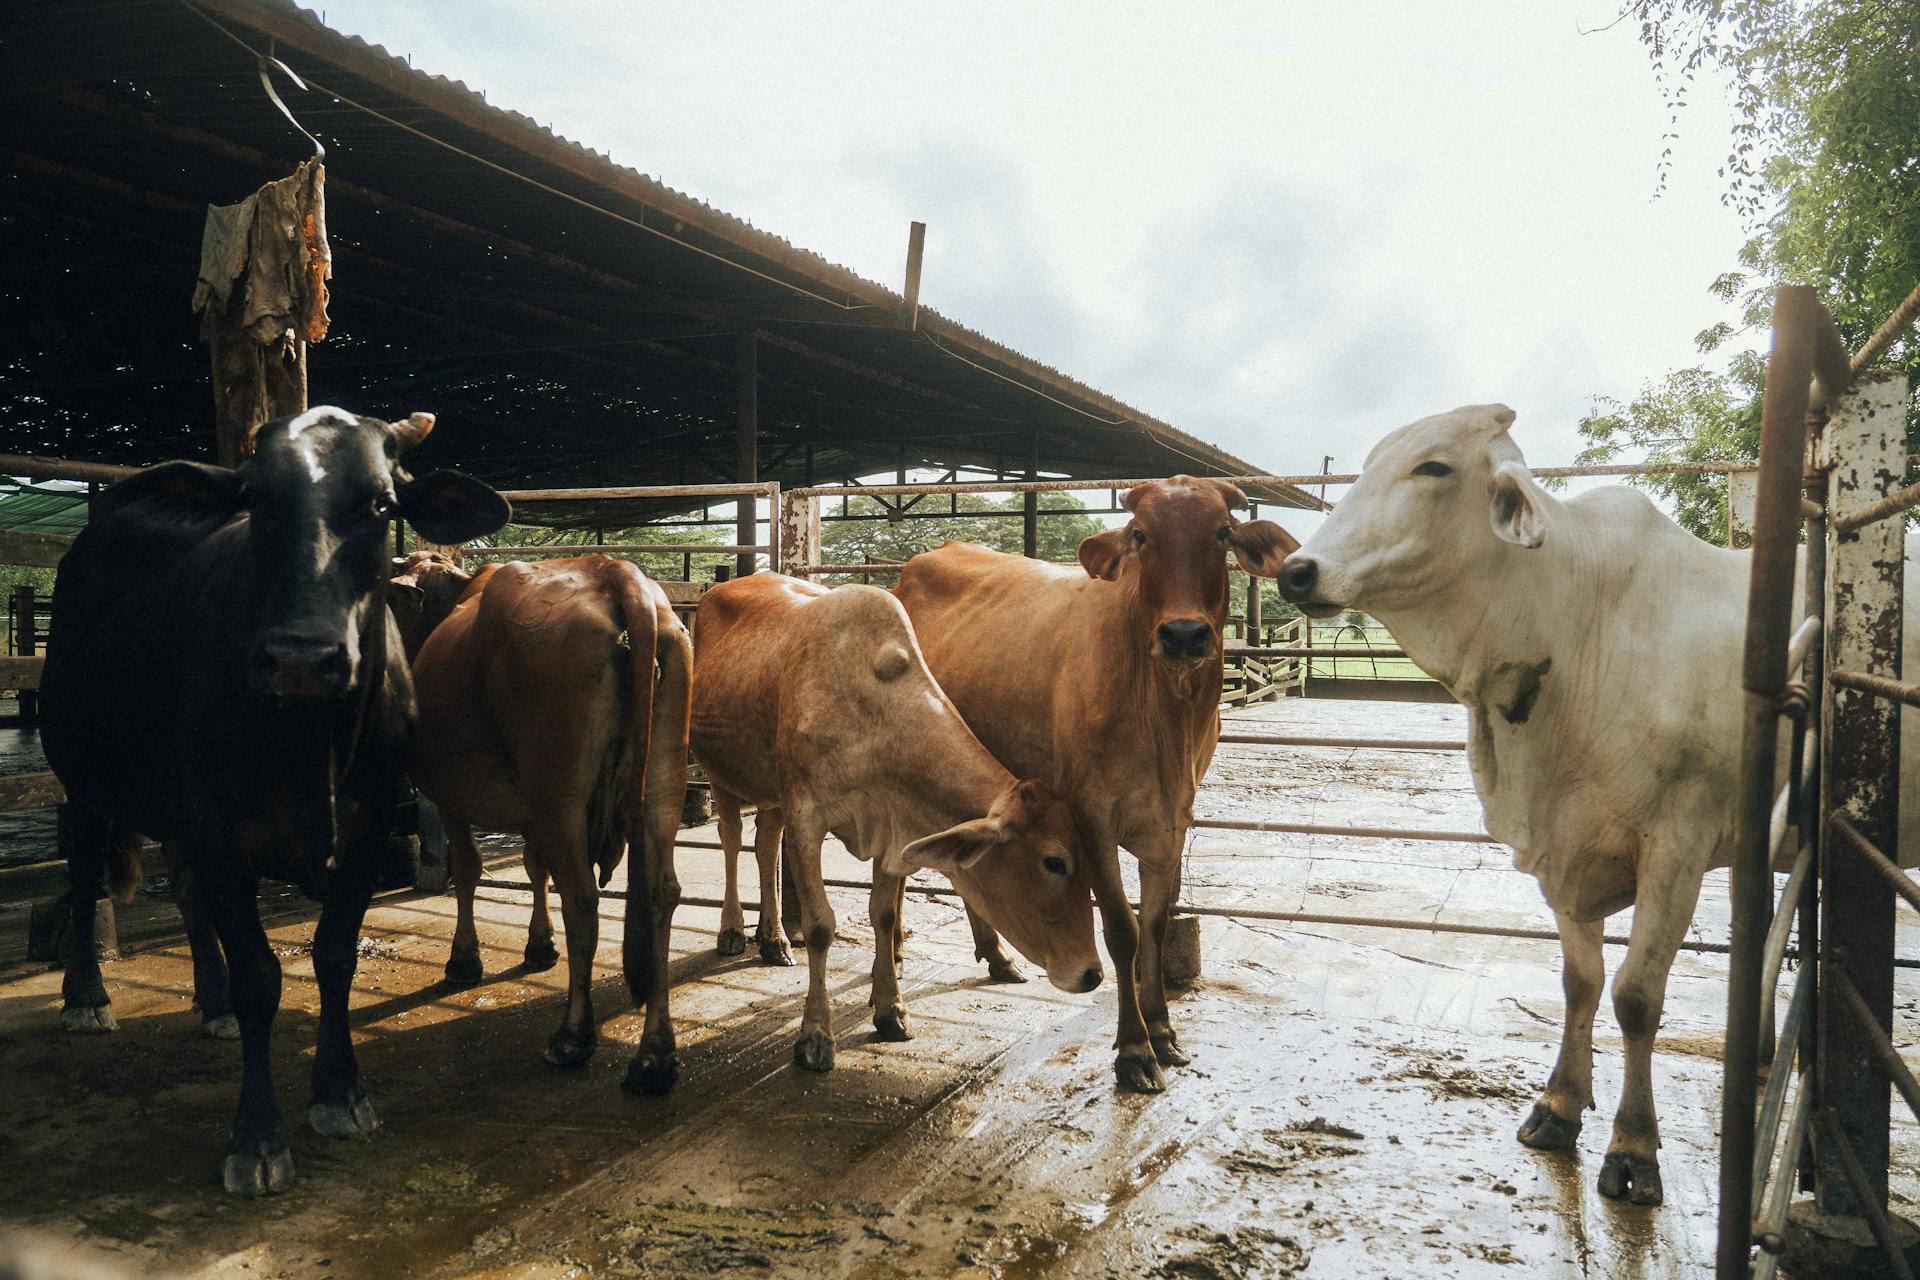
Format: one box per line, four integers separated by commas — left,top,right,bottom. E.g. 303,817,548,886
1580,0,1920,537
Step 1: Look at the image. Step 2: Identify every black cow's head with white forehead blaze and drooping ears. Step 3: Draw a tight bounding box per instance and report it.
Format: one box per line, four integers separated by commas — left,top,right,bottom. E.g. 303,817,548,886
148,407,511,702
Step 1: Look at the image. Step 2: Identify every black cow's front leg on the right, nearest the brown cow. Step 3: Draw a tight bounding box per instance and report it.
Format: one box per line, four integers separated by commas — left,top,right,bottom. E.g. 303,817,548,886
307,852,386,1138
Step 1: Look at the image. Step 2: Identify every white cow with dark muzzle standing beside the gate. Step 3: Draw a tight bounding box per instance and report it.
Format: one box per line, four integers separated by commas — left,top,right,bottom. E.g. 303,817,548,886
1279,405,1920,1205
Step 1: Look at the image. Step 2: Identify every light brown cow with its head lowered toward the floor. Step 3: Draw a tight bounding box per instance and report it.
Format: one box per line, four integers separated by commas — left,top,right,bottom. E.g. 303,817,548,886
691,574,1100,1071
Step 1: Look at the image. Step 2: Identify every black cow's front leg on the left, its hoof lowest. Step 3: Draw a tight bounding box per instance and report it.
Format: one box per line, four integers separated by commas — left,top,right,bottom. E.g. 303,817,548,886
201,848,295,1197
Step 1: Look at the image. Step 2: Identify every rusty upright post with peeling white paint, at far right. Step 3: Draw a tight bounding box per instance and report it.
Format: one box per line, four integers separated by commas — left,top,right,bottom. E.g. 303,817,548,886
1814,372,1907,1217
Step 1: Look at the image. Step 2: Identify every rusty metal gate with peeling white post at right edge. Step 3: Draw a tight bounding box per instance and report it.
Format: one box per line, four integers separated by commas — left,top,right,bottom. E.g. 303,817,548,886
1716,286,1920,1280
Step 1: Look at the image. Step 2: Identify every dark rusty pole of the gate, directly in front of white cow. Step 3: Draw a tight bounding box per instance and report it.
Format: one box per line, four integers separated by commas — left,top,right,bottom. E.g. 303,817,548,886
1715,286,1820,1280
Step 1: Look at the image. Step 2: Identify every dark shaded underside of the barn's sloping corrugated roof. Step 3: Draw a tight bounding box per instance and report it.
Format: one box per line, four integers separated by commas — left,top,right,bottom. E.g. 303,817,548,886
0,0,1317,526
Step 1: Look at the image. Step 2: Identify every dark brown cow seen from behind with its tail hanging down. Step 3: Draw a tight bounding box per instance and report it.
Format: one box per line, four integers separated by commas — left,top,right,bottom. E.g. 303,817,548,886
396,555,693,1092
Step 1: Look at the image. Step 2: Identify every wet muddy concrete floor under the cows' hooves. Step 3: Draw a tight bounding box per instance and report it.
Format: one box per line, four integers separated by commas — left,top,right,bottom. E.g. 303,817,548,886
0,700,1920,1278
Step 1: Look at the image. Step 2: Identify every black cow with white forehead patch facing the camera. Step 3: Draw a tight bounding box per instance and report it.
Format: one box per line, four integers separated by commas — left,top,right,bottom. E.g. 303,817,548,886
42,407,509,1196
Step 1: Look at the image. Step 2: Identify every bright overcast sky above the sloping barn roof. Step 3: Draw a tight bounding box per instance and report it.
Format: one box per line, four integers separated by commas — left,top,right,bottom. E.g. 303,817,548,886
309,0,1743,498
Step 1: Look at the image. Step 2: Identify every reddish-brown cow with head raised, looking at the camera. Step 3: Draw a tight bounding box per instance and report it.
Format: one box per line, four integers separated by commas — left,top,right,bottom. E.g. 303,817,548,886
897,476,1298,1092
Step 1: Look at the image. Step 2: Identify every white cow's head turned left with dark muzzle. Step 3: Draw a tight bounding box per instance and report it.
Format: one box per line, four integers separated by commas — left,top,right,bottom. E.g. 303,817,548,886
1279,405,1555,618
